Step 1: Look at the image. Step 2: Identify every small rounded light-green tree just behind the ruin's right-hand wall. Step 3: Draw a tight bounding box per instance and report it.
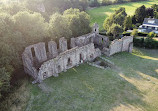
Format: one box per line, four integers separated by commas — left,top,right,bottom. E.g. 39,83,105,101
107,24,123,38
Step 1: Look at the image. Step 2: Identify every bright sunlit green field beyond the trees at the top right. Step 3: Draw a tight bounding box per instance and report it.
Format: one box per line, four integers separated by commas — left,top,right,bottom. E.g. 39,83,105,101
87,0,158,30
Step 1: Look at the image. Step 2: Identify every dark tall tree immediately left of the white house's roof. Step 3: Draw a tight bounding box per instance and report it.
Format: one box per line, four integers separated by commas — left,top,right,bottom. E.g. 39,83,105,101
135,5,146,23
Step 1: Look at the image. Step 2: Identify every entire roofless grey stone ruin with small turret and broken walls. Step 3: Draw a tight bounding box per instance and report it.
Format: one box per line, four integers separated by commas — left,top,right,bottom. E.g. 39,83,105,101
22,24,133,82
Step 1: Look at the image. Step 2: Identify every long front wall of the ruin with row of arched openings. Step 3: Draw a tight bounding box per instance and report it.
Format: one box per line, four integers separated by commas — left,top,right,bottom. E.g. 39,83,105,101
38,43,101,80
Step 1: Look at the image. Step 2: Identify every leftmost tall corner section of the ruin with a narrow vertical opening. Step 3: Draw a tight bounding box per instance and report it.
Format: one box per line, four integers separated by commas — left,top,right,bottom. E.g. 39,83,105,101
22,42,47,78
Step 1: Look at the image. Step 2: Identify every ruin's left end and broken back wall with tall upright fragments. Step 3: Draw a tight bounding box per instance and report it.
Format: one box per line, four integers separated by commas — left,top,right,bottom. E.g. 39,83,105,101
22,38,67,79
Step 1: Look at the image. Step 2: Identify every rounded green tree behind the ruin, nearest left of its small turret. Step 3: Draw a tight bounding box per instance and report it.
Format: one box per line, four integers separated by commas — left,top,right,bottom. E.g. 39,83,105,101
63,8,91,37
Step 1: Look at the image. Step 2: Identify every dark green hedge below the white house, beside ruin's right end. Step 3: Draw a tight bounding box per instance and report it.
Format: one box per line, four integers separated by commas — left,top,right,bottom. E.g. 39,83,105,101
133,38,158,49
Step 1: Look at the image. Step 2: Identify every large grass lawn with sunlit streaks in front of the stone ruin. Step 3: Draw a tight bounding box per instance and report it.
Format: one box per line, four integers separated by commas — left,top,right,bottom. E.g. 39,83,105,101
26,49,158,111
